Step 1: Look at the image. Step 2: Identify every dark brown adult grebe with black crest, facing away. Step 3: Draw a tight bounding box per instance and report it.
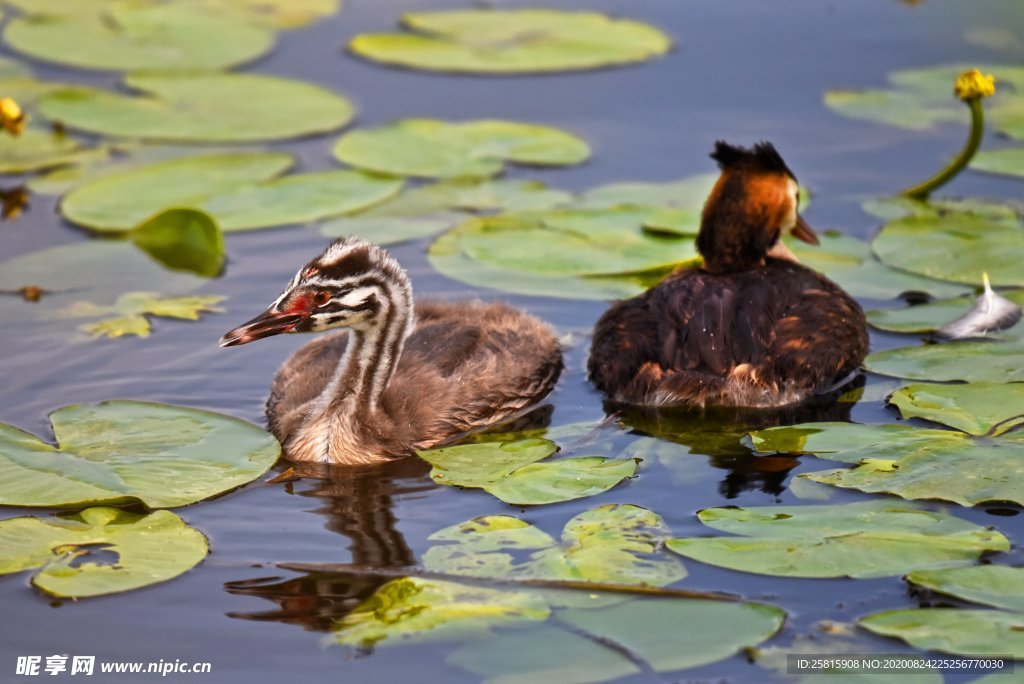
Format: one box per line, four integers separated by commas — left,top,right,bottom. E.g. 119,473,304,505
588,142,867,408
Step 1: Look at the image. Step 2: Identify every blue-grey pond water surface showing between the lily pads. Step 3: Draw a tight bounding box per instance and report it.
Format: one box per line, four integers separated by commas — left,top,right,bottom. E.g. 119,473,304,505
0,0,1024,684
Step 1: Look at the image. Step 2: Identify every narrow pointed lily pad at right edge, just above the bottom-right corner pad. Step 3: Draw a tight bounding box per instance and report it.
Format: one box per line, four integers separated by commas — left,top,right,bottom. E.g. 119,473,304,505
906,565,1024,612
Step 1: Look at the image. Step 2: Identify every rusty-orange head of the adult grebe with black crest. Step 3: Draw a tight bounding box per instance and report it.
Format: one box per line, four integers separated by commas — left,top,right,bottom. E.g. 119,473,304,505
697,140,818,271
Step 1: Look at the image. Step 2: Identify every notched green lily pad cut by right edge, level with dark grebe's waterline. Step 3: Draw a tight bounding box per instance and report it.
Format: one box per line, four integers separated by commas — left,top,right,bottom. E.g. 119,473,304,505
889,382,1024,436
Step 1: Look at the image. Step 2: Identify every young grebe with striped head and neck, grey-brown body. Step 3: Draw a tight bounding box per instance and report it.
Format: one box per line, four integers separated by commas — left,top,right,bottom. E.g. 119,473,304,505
221,239,562,464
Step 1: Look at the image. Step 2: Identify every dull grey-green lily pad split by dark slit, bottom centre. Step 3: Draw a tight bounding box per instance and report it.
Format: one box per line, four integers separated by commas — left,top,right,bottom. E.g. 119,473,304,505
447,599,785,684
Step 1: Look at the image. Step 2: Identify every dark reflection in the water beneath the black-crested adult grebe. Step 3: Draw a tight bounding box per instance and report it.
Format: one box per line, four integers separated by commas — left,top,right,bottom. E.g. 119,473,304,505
605,377,864,499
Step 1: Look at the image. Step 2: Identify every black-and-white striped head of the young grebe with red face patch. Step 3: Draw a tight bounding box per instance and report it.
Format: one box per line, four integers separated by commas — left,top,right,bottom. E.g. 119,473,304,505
220,238,413,347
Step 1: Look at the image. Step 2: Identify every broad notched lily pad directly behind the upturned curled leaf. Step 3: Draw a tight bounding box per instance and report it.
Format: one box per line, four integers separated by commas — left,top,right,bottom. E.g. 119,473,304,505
60,152,401,232
